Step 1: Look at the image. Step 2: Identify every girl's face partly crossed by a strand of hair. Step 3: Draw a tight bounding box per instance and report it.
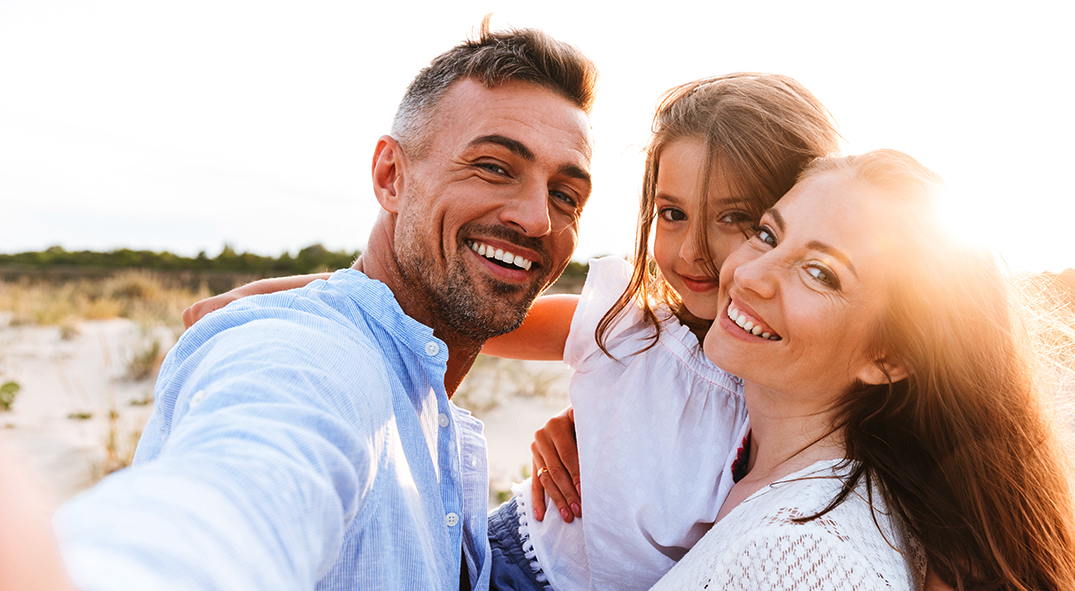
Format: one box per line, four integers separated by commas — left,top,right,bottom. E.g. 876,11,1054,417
654,139,753,320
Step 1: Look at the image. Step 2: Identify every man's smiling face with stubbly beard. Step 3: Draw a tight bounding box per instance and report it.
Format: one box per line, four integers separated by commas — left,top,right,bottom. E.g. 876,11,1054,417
395,80,591,341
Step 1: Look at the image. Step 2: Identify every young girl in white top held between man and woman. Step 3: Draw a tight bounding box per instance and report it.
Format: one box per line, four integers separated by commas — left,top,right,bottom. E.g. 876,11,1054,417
185,73,837,591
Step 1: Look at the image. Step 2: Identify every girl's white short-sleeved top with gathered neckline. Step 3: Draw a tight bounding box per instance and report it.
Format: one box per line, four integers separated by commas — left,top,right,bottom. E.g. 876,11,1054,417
515,258,747,591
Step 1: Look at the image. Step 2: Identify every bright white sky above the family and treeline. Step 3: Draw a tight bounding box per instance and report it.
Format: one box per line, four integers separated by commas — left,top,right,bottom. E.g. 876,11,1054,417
0,0,1075,271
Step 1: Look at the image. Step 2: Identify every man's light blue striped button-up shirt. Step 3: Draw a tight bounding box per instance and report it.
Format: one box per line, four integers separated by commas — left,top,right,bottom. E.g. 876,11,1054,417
55,270,489,591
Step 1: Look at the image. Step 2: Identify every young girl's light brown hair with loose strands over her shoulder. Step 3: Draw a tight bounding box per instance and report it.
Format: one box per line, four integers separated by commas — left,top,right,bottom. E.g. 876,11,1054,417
594,72,840,354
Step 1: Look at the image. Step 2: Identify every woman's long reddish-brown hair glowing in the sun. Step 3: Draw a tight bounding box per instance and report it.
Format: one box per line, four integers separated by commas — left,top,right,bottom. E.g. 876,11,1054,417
804,150,1075,591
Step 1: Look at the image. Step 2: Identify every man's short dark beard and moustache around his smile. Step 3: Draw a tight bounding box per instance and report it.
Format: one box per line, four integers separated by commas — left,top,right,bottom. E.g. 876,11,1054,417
393,222,548,342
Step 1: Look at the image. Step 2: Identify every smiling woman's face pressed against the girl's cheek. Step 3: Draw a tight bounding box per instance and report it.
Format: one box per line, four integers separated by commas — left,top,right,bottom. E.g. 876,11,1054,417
704,171,899,404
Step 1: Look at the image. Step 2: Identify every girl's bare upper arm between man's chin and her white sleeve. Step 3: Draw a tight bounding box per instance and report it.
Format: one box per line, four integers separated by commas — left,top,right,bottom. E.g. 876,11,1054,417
482,294,578,361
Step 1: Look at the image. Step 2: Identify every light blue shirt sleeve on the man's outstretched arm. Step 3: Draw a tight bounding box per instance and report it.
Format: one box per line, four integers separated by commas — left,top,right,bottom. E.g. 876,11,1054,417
55,320,387,591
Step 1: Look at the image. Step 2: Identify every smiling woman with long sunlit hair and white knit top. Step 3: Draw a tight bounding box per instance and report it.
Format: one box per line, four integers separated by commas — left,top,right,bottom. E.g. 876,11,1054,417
655,150,1075,590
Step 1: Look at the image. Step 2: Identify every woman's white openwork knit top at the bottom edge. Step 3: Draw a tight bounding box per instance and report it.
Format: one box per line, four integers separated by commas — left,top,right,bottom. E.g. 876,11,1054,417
654,460,926,591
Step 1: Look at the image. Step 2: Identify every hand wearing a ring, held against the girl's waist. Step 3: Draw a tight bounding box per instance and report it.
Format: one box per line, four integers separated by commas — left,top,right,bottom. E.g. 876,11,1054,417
530,406,583,523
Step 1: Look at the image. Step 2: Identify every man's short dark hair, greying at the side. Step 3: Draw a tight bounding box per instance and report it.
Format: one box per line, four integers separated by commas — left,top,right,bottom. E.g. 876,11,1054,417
392,16,598,158
